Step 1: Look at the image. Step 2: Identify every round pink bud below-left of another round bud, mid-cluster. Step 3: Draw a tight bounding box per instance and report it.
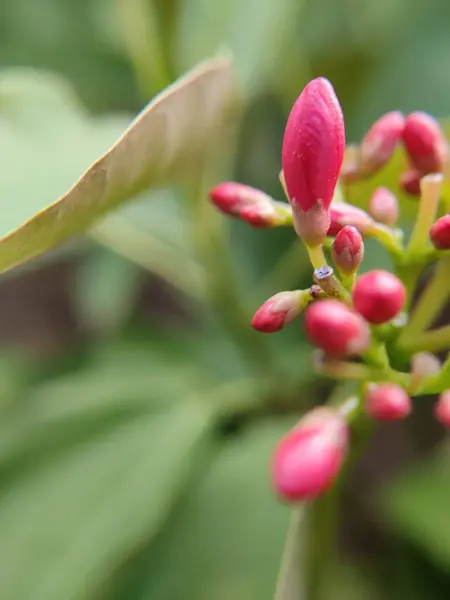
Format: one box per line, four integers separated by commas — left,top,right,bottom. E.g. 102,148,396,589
305,299,370,356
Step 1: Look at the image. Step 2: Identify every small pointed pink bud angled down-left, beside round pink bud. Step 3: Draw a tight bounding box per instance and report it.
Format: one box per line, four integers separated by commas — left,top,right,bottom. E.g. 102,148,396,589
252,290,306,333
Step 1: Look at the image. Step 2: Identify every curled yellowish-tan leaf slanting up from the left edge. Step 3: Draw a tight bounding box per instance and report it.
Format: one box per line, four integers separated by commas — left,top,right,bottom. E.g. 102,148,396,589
0,58,233,272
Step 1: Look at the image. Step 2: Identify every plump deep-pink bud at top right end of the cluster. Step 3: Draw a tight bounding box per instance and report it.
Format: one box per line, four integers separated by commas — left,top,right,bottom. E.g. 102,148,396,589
403,112,448,174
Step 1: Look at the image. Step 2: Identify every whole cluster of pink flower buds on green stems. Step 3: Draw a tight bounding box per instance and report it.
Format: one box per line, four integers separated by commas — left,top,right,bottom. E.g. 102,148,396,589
210,78,450,501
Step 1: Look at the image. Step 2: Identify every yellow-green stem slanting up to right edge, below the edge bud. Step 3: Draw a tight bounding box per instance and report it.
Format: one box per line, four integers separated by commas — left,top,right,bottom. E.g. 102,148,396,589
399,256,450,344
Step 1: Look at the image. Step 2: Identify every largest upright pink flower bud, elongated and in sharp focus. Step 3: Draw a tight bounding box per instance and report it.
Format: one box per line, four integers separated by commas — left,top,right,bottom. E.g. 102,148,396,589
282,77,345,245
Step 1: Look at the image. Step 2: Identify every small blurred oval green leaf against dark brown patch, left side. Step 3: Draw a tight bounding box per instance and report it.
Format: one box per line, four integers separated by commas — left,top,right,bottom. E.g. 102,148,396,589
74,248,141,333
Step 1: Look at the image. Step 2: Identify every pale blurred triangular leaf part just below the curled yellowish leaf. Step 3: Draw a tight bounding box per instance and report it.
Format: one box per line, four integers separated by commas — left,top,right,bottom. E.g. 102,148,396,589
90,188,204,298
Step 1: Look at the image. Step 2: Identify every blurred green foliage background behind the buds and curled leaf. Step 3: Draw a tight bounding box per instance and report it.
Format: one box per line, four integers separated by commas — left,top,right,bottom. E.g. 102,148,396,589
0,0,450,600
